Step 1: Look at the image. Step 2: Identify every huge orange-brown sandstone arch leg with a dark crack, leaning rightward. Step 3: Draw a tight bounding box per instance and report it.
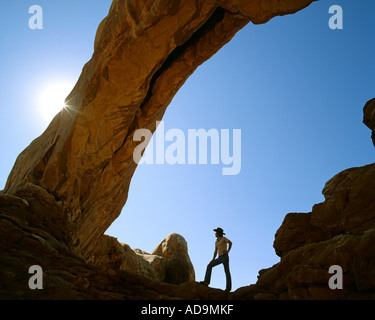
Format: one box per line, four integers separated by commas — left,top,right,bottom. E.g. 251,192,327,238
4,0,312,259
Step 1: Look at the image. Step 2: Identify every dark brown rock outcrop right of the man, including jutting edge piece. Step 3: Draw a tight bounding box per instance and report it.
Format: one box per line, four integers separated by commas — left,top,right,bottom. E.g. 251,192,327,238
232,99,375,299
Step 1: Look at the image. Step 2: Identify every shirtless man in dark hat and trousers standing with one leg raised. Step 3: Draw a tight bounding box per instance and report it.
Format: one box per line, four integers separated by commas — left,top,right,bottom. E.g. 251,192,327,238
200,228,232,292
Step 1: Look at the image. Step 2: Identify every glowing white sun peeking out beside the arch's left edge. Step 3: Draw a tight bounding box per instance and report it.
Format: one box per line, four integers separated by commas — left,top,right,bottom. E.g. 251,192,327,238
38,81,73,121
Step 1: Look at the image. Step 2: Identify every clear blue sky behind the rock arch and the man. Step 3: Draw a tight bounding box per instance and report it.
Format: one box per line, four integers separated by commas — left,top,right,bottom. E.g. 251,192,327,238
0,0,375,289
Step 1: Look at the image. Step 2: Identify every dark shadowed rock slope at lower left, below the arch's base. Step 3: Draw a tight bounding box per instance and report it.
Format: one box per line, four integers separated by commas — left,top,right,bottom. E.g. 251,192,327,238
0,195,220,299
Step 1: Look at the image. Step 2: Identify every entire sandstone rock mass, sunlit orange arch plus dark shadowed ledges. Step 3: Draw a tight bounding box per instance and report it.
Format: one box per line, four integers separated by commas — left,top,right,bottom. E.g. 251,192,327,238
0,0,375,299
